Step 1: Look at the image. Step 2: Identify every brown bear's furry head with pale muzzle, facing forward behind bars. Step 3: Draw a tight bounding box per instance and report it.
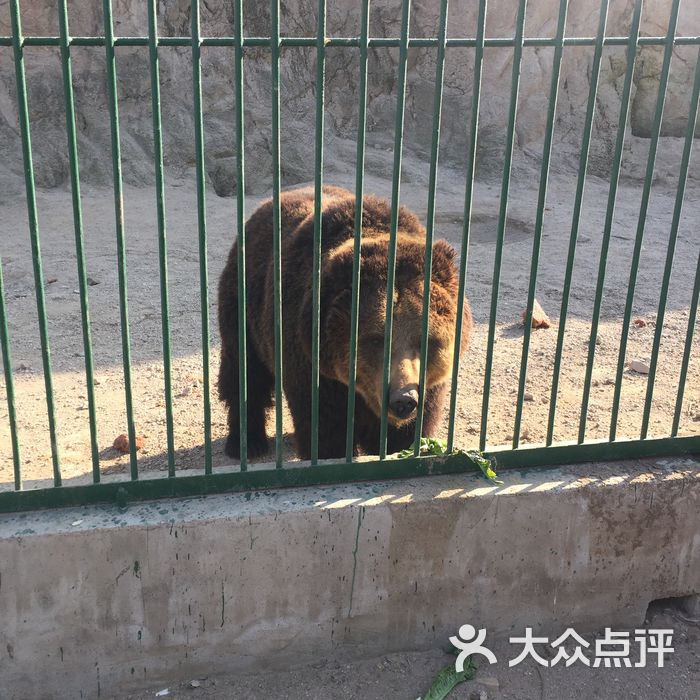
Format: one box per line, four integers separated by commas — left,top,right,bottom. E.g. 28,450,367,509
302,232,471,426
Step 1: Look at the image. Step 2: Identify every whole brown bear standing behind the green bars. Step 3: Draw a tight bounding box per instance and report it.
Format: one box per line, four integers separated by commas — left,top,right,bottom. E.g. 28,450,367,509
218,187,473,459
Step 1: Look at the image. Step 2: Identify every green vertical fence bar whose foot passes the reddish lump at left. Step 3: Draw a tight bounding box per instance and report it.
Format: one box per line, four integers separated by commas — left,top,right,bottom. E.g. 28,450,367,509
102,0,139,481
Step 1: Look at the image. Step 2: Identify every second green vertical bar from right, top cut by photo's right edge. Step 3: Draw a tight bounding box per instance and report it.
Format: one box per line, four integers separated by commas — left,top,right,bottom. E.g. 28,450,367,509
640,45,700,440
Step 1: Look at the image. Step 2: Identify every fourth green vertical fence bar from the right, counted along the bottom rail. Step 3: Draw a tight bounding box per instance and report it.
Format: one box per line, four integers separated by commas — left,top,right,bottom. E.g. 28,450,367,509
578,0,643,444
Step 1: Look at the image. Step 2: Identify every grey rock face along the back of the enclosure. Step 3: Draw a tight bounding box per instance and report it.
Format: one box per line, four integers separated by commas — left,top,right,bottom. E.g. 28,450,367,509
0,0,700,196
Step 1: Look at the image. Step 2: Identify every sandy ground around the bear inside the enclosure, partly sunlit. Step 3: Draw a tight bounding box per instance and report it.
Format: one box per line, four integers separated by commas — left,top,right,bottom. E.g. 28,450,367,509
0,166,700,488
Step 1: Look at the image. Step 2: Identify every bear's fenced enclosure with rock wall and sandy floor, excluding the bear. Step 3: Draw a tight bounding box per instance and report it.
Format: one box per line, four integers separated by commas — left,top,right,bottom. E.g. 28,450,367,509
0,0,700,510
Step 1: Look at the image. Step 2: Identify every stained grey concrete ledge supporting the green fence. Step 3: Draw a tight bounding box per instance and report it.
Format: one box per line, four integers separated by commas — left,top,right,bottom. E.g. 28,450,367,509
0,459,700,700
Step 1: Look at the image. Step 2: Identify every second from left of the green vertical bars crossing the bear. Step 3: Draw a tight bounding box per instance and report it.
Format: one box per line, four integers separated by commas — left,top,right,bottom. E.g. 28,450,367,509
270,0,283,469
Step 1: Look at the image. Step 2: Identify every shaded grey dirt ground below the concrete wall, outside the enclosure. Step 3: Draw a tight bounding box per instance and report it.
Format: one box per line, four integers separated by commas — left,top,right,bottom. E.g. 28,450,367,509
116,606,700,700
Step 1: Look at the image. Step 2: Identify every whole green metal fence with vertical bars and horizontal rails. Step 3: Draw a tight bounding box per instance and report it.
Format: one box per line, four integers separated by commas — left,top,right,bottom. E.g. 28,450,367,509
0,0,700,511
